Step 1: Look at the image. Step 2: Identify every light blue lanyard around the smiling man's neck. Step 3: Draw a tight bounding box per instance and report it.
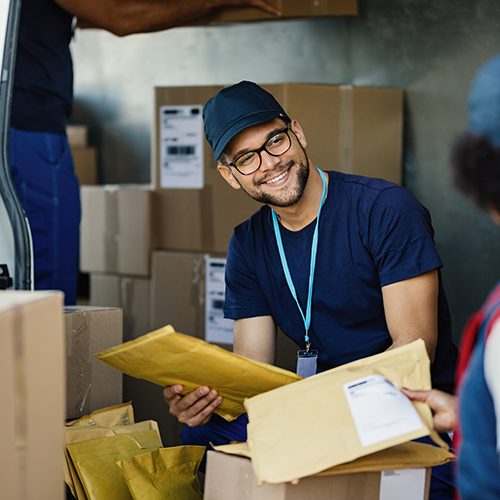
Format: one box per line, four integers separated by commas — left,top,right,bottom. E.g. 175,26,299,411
271,167,326,351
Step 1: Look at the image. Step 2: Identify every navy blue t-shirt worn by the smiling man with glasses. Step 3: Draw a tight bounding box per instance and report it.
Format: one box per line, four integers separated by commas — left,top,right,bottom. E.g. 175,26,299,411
224,172,456,392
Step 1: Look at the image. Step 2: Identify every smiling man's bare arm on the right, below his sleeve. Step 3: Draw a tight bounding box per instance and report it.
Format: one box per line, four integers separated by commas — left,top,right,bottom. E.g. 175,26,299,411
382,270,439,362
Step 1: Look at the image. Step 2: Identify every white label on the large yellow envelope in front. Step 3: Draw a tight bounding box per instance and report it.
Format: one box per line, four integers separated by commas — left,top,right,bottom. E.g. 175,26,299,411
344,375,423,446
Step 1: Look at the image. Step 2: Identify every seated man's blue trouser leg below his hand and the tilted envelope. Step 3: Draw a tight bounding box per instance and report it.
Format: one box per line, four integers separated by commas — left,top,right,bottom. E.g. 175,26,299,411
181,413,248,472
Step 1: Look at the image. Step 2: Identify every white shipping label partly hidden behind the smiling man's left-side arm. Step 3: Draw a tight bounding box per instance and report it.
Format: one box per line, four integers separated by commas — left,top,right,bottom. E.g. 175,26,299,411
205,257,233,344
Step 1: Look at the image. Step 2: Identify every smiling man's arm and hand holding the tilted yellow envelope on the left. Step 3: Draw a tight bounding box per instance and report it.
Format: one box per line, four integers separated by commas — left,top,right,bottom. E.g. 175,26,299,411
163,316,276,427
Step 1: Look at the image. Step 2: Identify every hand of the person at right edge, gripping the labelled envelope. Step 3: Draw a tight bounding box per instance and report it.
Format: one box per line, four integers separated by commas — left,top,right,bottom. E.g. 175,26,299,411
401,389,458,432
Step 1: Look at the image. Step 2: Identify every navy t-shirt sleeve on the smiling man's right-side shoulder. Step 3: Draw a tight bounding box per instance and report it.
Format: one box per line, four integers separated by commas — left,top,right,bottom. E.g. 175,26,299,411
369,186,442,286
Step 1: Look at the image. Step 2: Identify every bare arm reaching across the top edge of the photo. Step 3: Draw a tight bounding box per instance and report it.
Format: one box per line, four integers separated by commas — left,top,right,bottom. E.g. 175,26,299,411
55,0,280,36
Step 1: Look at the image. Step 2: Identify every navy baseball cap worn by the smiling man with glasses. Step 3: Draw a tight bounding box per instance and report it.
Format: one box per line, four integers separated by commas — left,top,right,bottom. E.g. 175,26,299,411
203,81,290,160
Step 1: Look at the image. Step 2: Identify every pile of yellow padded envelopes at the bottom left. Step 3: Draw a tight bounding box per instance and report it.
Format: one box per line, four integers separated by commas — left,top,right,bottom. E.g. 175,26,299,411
65,403,205,500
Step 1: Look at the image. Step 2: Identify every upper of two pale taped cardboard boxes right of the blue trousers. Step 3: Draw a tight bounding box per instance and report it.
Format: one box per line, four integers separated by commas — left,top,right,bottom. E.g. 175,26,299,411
80,185,155,277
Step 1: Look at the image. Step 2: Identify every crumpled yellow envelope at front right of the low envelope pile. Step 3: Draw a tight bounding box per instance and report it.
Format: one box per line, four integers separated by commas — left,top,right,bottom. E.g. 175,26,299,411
117,446,205,500
